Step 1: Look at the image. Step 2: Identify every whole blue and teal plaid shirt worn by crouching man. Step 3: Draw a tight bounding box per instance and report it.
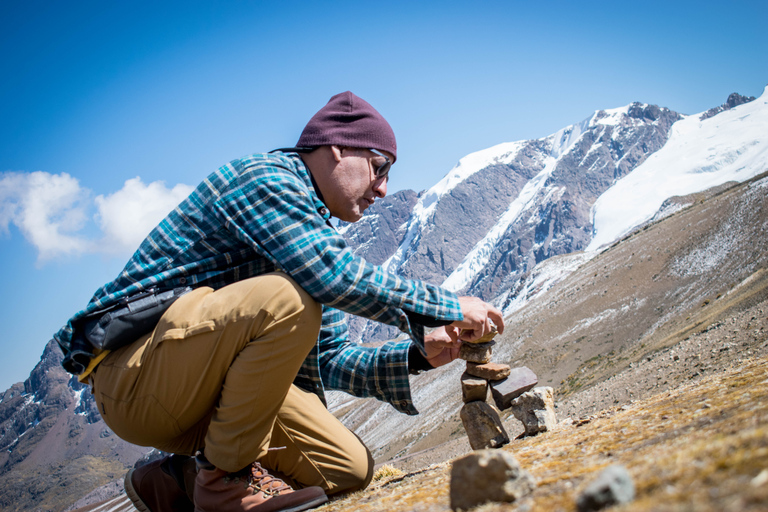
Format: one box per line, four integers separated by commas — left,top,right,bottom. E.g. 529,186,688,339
54,152,462,414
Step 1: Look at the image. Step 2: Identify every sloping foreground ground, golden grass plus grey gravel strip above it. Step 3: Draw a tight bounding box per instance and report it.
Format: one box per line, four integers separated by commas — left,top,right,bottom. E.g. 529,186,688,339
318,303,768,512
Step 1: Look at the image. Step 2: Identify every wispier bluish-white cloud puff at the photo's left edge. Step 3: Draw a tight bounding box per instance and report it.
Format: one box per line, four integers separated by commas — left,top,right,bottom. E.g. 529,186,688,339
0,171,90,261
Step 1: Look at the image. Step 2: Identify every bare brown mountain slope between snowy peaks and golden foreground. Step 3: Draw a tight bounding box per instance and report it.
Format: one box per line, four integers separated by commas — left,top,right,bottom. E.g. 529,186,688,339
331,168,768,462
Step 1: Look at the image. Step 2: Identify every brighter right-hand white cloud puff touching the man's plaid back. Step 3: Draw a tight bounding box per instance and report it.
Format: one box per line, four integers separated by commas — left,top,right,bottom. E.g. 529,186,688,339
95,177,192,253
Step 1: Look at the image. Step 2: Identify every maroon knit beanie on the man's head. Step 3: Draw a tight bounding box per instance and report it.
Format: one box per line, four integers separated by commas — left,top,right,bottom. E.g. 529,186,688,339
296,91,397,160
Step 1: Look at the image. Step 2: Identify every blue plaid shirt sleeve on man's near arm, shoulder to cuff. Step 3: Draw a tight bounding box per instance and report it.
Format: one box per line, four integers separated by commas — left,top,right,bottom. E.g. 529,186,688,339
215,159,462,351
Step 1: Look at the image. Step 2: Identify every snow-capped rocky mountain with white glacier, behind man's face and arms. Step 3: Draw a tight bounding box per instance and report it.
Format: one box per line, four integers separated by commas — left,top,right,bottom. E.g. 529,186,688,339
343,88,768,341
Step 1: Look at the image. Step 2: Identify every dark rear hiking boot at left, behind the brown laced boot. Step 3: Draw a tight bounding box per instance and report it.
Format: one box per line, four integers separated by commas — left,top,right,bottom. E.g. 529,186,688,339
125,455,196,512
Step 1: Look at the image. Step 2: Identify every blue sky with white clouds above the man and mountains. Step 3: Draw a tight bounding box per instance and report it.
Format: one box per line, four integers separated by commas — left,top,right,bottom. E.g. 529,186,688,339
0,0,768,391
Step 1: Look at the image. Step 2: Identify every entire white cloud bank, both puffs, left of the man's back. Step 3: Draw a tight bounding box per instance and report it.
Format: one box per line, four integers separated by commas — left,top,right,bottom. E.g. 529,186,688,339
0,171,192,263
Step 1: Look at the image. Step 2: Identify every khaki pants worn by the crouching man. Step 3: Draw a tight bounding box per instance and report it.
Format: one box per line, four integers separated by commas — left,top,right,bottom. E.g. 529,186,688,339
93,274,373,493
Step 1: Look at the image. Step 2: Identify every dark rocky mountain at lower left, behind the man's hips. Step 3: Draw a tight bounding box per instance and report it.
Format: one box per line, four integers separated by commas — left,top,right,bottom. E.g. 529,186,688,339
0,342,147,511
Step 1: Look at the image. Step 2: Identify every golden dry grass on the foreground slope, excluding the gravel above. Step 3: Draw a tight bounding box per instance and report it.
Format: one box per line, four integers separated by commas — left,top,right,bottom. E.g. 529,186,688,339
319,358,768,512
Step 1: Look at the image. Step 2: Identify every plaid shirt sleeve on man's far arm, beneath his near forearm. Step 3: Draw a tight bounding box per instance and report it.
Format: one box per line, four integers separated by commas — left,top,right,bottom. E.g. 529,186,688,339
319,308,418,415
